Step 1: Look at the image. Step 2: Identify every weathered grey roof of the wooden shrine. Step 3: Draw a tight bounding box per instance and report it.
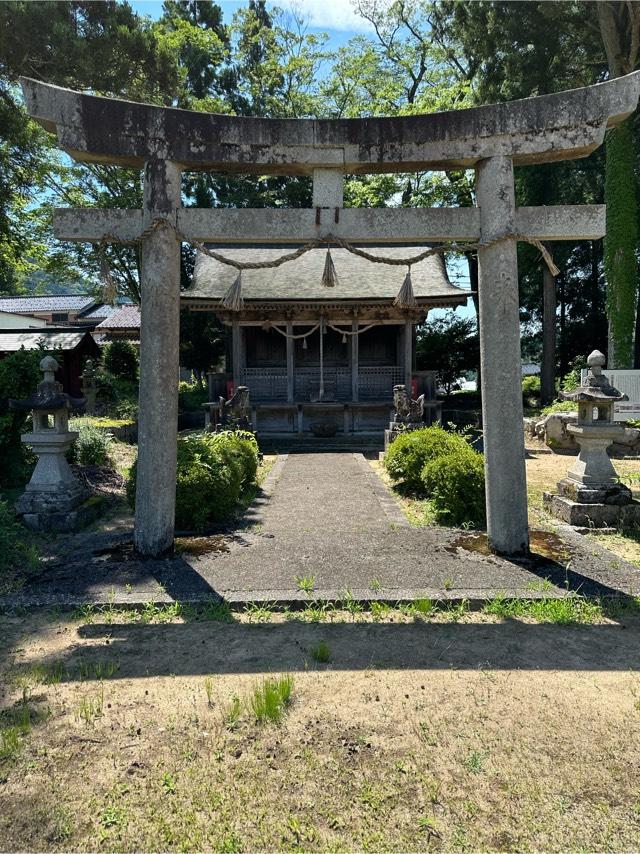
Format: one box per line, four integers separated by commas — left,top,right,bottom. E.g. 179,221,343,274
182,245,470,306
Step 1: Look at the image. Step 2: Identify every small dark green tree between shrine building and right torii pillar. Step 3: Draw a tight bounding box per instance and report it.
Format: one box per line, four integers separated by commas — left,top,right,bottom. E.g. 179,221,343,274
416,311,479,395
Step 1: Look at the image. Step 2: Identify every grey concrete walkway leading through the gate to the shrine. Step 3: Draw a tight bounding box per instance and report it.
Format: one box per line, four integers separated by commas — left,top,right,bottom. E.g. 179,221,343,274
0,453,640,605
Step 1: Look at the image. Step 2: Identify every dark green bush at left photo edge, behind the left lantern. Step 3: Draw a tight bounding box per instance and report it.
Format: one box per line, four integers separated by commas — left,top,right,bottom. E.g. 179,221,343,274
0,349,45,486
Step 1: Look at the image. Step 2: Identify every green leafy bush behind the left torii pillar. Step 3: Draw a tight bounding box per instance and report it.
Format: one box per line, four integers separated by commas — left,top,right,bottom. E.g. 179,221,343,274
127,432,258,531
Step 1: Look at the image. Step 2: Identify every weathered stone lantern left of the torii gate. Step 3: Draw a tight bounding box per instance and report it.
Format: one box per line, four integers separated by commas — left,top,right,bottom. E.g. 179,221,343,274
9,356,89,530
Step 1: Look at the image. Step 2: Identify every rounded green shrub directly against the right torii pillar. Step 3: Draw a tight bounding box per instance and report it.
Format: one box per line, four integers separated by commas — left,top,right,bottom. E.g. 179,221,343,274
422,445,486,528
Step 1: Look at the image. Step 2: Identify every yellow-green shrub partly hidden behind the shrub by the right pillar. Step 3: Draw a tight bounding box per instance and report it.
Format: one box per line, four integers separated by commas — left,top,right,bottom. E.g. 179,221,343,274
384,425,469,492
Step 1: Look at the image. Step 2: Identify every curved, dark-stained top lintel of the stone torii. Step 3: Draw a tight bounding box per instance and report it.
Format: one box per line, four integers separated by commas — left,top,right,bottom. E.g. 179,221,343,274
21,71,640,175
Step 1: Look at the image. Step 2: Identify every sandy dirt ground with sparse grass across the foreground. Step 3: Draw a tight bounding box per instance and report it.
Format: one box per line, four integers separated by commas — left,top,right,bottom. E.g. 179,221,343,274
0,613,640,851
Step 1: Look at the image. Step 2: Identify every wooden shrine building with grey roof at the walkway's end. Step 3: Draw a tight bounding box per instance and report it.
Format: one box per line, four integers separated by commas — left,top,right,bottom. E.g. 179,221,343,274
182,244,469,436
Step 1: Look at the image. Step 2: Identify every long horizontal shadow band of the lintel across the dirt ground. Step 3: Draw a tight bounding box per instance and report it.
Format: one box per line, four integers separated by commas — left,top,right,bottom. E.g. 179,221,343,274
13,615,640,679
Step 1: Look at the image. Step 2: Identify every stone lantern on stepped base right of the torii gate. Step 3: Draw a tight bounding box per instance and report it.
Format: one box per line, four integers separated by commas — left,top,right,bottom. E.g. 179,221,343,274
543,350,640,528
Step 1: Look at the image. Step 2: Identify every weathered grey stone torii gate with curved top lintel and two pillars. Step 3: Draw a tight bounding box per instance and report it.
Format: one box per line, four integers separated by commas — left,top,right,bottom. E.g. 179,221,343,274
21,72,640,555
